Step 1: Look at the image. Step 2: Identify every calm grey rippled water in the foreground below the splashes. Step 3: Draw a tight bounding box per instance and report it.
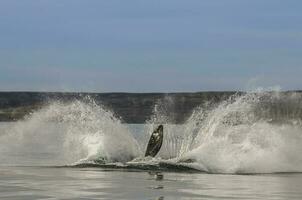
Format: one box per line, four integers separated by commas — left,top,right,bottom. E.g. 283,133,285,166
0,167,302,200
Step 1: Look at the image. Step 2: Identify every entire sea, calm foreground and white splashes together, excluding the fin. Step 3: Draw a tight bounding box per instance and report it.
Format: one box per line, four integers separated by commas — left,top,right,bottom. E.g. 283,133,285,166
0,92,302,199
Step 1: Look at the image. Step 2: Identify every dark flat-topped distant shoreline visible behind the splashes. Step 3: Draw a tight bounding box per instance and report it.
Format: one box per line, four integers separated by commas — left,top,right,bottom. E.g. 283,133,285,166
0,90,301,123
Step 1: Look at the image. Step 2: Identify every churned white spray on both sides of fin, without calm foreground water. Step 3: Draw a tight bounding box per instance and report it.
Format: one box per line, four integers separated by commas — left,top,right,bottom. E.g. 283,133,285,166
0,92,302,173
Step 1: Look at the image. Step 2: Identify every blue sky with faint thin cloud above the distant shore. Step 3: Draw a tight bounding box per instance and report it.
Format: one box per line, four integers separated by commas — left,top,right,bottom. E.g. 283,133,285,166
0,0,302,92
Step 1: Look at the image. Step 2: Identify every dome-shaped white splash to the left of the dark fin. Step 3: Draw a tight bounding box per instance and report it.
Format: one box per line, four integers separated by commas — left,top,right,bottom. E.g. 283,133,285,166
0,99,140,165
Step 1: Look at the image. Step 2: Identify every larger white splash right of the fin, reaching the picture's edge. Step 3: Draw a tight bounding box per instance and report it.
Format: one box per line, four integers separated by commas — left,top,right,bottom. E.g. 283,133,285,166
178,92,302,173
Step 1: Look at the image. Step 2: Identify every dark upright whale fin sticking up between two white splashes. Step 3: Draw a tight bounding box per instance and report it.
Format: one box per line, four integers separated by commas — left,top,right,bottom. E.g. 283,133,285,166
145,125,164,157
